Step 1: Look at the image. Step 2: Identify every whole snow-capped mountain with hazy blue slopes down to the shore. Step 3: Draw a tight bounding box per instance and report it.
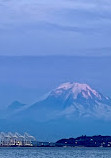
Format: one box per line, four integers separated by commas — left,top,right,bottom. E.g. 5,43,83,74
0,82,111,140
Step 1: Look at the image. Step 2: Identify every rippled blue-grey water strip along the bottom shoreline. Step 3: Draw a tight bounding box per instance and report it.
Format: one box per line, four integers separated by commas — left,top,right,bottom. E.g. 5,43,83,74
0,148,111,158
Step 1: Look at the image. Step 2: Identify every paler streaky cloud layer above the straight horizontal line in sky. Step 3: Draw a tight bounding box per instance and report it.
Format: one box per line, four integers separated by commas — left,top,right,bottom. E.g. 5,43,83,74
0,0,111,56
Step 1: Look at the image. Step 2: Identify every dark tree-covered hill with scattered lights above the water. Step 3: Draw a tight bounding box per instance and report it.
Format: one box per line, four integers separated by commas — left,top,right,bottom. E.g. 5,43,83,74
56,135,111,147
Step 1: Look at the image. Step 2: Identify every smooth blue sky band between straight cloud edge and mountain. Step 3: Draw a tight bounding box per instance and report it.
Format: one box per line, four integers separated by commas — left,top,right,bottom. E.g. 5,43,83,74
0,56,111,108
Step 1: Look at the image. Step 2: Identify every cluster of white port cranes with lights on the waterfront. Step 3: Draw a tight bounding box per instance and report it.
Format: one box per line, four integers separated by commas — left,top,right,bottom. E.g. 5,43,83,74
0,132,36,146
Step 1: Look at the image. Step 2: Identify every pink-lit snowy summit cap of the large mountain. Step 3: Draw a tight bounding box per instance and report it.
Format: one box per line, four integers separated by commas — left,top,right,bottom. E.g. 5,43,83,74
54,82,102,100
